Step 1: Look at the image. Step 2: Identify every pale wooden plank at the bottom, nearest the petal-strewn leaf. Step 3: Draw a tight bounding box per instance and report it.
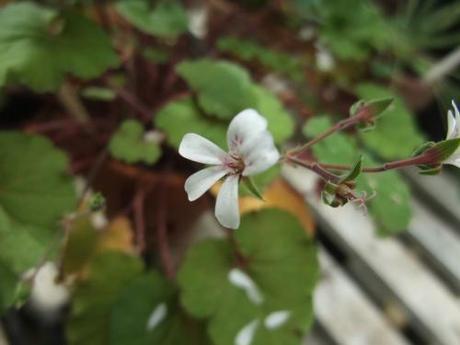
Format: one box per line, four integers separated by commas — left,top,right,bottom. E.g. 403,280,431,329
314,249,407,345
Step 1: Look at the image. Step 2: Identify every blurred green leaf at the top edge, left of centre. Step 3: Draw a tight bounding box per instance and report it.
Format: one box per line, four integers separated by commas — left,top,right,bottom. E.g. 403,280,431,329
116,0,188,38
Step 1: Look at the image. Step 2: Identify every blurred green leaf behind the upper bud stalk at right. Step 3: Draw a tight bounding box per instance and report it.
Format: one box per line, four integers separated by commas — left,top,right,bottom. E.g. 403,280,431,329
356,84,424,159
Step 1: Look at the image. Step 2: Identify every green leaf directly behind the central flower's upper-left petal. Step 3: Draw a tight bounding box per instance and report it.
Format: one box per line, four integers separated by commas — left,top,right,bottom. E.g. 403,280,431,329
154,98,227,148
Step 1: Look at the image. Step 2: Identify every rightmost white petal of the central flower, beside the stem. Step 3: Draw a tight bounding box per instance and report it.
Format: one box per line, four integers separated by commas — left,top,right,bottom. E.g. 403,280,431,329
243,131,280,176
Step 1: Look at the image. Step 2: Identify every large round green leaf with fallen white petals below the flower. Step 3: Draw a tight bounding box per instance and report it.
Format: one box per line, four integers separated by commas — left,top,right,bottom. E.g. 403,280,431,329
178,210,318,345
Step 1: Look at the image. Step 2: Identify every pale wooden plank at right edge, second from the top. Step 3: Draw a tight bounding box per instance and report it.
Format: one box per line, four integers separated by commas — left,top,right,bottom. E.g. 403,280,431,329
408,200,460,294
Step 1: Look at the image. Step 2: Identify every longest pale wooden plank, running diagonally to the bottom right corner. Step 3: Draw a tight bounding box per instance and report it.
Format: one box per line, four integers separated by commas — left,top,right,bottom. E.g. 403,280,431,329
284,167,460,345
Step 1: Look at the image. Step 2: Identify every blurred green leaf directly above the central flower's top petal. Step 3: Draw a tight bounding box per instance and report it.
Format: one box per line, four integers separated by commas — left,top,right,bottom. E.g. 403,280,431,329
176,59,257,120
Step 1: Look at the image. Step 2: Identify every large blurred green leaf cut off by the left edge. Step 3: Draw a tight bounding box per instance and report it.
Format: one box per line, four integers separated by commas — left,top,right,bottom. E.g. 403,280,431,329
0,131,75,310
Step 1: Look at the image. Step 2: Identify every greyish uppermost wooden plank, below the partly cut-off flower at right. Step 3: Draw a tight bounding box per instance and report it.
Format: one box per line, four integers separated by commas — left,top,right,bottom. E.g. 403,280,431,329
404,169,460,226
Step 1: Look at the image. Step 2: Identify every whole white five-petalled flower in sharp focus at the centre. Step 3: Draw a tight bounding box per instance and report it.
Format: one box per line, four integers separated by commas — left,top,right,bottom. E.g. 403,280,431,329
179,109,280,229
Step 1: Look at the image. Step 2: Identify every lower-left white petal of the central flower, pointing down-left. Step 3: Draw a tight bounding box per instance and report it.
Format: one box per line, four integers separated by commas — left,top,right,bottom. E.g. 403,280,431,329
184,165,228,201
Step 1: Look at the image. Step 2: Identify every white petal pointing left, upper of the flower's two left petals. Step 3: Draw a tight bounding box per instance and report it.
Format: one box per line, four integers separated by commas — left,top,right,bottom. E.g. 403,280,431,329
179,133,227,164
